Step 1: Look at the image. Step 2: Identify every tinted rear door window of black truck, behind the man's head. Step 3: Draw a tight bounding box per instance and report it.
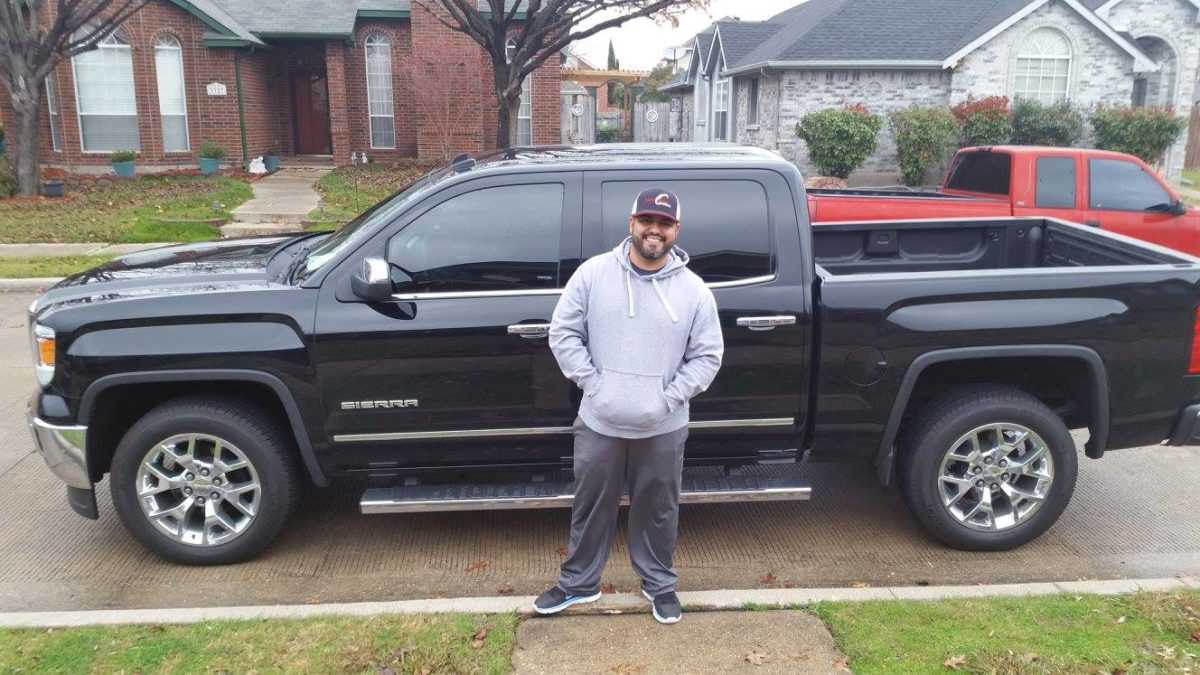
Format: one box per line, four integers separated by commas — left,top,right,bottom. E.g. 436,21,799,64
601,180,773,283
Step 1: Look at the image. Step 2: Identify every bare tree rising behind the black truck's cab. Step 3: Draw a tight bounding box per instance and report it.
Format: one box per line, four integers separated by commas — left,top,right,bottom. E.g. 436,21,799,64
413,0,708,148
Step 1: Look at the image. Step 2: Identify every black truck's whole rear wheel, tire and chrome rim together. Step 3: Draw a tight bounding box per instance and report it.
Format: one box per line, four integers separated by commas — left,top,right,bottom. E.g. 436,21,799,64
900,387,1079,551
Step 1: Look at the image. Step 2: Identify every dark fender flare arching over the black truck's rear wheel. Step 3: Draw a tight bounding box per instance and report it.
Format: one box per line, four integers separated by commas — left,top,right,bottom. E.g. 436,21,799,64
875,345,1110,485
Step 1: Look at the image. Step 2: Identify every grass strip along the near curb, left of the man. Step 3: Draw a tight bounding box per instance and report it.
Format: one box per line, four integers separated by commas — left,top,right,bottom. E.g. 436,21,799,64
0,614,517,674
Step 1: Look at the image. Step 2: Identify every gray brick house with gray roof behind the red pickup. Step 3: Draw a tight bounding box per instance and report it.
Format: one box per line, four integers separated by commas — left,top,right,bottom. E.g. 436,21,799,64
667,0,1200,181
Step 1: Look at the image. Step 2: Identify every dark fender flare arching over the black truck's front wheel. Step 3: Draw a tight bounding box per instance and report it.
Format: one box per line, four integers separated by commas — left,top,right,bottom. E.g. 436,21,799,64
79,369,329,488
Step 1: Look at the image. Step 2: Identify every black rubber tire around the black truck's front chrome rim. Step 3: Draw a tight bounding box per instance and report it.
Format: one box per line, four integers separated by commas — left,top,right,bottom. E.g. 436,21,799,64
109,396,301,565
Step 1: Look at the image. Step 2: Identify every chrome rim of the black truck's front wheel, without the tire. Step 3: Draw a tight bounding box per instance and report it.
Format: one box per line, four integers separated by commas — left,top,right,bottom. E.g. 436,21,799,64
134,434,263,546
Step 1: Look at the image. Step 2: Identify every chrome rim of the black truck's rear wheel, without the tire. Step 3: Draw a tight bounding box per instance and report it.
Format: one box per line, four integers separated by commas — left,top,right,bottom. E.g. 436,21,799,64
937,423,1054,532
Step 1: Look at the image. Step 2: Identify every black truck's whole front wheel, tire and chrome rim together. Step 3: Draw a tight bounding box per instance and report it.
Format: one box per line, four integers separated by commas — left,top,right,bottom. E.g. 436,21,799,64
110,398,300,565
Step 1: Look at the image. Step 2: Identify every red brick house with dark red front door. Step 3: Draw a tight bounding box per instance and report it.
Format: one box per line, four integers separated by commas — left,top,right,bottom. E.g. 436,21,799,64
0,0,560,171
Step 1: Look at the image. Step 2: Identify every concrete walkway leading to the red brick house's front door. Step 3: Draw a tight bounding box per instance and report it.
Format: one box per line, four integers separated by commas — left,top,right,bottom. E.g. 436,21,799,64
221,168,329,237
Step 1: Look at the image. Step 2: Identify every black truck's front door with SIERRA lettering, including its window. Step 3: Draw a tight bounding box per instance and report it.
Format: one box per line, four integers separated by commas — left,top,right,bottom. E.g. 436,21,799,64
314,174,581,476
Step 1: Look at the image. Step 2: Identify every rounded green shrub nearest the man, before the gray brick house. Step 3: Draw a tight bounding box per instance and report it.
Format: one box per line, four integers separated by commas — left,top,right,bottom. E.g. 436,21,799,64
796,106,883,179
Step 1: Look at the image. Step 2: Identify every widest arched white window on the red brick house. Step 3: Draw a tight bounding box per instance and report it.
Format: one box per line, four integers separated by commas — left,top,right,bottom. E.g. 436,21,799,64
71,28,142,153
